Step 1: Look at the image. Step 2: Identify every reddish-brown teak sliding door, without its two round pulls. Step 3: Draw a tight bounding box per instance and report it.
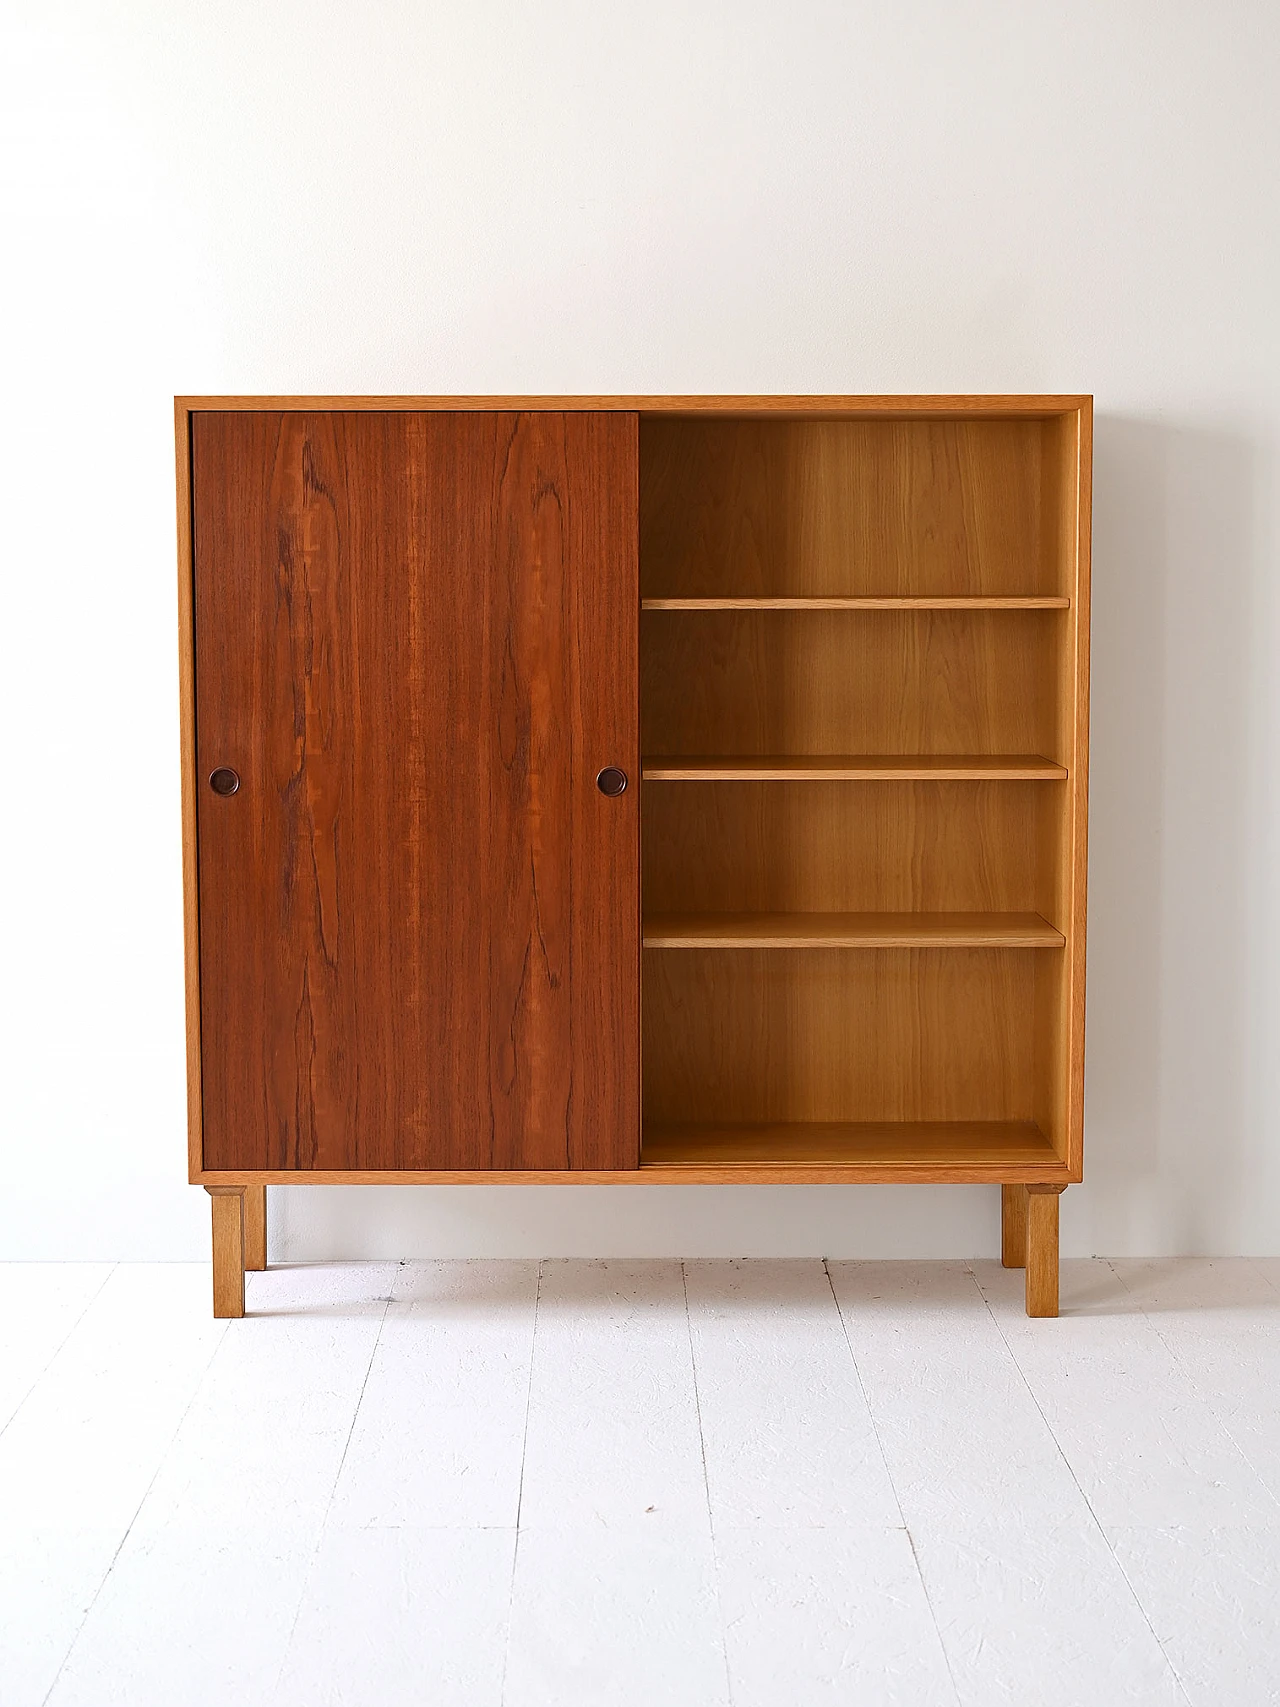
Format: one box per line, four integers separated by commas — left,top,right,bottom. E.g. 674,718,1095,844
193,411,638,1171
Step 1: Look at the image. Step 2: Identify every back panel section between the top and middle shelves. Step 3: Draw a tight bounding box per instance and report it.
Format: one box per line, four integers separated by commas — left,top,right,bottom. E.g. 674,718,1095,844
640,611,1067,760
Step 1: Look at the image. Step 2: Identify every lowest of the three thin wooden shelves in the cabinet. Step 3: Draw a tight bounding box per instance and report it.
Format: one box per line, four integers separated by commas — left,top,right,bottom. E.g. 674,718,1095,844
642,913,1067,949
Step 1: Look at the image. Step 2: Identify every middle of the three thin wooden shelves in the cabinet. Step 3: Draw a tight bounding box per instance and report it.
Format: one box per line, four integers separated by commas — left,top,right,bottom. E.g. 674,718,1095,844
640,753,1067,782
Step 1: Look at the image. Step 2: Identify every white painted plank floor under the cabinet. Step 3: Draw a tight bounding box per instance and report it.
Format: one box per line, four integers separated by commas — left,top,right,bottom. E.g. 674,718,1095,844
0,1260,1280,1707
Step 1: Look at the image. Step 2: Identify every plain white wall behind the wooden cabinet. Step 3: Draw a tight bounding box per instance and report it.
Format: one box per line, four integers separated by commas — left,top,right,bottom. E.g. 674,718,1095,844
0,0,1280,1258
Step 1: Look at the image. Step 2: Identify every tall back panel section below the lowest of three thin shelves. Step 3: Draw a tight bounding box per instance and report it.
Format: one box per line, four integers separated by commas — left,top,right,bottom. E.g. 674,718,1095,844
643,949,1053,1123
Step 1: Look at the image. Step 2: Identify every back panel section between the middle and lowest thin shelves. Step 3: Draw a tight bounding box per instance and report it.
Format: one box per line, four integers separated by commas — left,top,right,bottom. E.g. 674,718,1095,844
643,782,1060,923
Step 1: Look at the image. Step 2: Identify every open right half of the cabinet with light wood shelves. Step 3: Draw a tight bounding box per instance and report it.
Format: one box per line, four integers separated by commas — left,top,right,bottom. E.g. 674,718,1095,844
640,399,1089,1186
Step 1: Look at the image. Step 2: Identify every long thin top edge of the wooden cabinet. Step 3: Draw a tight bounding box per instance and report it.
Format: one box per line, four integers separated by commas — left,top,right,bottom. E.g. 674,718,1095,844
174,394,1092,420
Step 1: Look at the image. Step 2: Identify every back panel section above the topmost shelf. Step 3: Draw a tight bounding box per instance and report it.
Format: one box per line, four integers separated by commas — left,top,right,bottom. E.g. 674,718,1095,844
640,417,1070,597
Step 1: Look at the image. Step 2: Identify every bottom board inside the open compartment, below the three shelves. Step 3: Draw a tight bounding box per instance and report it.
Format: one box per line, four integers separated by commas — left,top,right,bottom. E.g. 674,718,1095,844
640,1120,1067,1185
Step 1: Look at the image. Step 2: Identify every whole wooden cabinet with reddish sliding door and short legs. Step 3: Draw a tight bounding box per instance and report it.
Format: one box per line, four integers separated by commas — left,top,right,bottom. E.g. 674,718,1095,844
177,396,1092,1314
